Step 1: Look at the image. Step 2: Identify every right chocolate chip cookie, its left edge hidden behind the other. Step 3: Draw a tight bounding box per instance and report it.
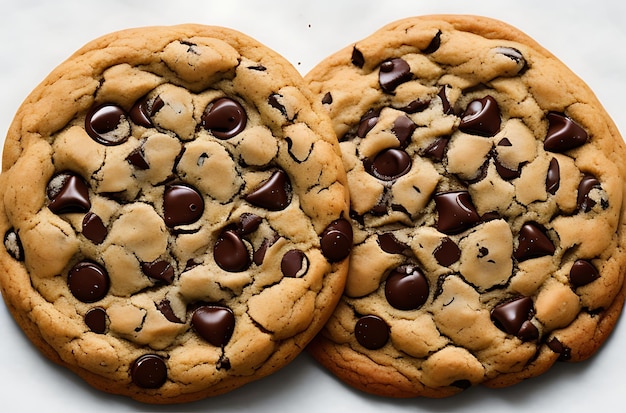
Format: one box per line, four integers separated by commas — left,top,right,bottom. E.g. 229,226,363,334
306,16,626,397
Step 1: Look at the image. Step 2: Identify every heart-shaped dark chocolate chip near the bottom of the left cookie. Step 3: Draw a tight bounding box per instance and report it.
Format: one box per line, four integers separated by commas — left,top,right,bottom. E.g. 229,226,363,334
191,305,235,347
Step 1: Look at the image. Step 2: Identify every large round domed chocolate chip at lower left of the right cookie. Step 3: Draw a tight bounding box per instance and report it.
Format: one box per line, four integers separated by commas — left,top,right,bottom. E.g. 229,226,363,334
385,266,429,311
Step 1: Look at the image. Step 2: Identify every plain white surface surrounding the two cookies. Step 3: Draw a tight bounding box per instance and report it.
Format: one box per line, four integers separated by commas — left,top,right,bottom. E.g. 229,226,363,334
0,0,626,413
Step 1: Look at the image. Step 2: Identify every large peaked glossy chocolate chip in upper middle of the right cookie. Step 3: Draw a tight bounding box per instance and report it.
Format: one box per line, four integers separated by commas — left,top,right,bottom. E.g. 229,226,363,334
459,96,501,136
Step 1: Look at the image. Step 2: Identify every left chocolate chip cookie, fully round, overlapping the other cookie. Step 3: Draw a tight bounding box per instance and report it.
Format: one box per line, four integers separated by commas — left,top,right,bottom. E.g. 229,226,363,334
0,25,352,403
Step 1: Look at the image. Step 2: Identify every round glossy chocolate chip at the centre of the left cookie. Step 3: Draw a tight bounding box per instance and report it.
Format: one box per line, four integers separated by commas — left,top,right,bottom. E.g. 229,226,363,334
163,184,204,228
